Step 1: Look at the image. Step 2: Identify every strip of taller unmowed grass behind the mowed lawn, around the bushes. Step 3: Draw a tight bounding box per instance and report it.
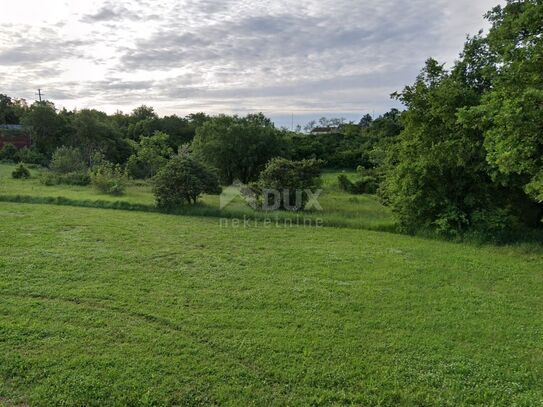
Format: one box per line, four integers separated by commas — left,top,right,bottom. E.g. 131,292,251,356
0,164,395,231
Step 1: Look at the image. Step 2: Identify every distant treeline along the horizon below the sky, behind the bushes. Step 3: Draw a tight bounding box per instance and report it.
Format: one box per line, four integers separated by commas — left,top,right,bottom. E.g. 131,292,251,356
0,95,401,183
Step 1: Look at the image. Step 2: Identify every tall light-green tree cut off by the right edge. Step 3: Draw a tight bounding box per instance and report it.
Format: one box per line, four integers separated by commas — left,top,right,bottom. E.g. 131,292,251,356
460,0,543,214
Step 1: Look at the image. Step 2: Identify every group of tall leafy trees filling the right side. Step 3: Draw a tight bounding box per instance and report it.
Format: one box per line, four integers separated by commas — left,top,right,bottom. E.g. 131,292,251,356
380,0,543,239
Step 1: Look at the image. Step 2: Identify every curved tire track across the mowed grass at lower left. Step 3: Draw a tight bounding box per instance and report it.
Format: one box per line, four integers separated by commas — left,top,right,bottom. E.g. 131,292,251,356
0,291,298,405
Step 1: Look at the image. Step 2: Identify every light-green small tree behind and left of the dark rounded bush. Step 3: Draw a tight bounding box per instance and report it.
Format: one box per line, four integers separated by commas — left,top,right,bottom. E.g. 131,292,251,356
126,132,174,179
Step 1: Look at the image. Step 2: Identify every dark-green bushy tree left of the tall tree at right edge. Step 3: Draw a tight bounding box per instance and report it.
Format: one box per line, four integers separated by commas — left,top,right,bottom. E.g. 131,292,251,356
382,59,498,233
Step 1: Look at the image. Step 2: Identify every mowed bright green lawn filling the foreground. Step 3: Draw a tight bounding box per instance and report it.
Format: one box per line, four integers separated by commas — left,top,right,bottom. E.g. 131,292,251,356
0,203,543,406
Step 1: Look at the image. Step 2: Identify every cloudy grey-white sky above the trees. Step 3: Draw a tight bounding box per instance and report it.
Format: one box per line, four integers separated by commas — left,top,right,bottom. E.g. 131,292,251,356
0,0,501,126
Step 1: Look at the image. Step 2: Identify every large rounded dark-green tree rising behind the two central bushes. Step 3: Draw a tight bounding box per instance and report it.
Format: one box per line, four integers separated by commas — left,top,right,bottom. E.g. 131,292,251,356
193,114,286,184
